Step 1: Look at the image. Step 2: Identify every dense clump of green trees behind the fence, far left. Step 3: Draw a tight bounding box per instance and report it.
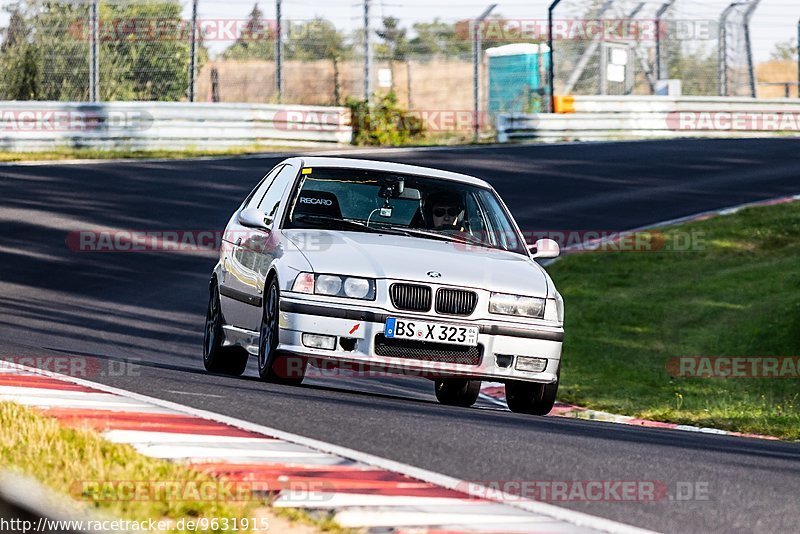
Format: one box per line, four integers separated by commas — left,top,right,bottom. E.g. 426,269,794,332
0,0,195,101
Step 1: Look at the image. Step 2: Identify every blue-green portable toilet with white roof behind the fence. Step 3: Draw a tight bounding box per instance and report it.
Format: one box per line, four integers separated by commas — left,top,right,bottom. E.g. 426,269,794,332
486,43,550,116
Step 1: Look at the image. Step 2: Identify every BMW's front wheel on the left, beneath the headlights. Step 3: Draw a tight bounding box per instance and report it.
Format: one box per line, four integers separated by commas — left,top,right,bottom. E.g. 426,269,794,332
258,278,307,386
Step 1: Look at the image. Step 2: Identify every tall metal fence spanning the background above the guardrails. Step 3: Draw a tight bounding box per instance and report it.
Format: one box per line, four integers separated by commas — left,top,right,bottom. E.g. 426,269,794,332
0,0,800,119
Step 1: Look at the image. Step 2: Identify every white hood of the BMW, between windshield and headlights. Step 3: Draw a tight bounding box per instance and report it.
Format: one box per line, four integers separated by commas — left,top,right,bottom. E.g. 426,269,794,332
283,229,548,297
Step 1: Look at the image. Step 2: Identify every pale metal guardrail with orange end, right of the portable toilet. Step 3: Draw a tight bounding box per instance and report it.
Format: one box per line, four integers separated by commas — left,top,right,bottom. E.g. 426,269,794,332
495,96,800,142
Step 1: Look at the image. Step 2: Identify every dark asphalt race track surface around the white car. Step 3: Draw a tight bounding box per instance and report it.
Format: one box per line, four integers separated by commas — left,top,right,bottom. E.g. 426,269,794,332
0,140,800,533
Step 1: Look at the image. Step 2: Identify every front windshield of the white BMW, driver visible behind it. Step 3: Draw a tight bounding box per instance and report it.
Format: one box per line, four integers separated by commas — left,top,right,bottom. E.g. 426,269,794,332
284,167,527,255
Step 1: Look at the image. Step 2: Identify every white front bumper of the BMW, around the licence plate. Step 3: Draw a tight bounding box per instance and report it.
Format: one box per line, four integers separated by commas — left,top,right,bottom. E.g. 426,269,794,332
278,294,564,383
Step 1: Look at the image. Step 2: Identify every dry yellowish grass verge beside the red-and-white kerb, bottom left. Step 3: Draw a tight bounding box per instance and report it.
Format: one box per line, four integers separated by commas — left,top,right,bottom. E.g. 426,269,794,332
0,402,348,533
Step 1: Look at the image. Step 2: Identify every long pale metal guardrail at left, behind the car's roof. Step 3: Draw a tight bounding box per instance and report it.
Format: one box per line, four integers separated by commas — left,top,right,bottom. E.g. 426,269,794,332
0,101,352,151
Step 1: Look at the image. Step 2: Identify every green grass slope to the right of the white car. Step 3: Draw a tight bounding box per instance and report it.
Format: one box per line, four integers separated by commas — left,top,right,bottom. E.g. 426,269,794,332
548,202,800,439
